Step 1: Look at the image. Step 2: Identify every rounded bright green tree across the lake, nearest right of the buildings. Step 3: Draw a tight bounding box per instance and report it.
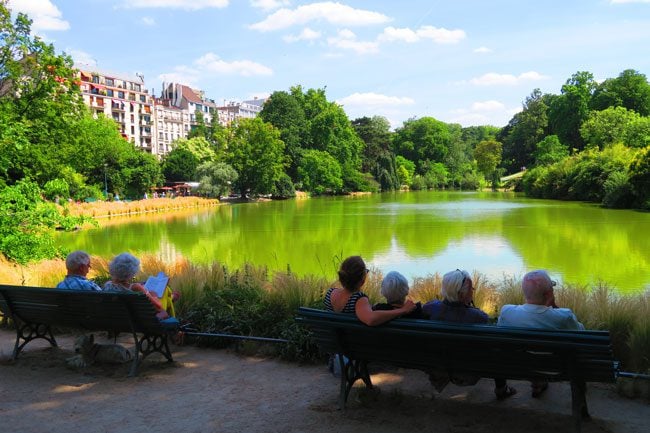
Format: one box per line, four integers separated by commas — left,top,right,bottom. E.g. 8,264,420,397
227,118,285,197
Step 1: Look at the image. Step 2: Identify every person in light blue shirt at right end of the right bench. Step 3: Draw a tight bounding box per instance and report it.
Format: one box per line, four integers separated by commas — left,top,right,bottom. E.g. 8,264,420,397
497,270,585,398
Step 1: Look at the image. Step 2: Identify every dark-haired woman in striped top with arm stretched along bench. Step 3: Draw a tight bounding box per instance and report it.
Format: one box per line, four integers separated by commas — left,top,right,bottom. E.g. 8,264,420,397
324,256,416,326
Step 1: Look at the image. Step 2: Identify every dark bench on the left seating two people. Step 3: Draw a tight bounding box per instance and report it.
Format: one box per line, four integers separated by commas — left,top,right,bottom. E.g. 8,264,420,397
0,285,178,376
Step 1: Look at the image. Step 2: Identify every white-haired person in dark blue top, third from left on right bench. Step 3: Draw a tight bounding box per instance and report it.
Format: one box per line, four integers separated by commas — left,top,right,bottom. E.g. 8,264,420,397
422,269,517,400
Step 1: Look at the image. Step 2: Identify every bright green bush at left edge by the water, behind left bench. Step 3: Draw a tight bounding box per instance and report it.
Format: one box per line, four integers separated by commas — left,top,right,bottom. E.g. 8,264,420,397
0,180,87,264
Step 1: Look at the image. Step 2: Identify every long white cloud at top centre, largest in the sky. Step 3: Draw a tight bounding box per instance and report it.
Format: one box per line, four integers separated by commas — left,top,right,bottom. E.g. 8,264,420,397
250,2,390,32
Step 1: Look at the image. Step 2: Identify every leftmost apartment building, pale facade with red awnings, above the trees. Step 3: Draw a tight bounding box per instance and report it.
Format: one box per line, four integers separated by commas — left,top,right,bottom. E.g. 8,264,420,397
79,68,158,154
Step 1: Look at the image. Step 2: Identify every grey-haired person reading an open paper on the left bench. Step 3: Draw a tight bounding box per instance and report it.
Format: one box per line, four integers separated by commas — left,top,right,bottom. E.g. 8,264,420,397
104,253,169,320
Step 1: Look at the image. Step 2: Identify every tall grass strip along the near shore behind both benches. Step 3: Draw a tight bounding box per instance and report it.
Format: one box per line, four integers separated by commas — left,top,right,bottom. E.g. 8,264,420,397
0,256,650,373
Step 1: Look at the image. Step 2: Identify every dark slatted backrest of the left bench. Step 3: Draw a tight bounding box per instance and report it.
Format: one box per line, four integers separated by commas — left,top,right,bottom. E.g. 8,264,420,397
0,285,161,333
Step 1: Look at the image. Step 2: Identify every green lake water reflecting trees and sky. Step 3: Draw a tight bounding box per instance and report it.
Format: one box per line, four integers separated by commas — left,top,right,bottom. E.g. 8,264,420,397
57,192,650,293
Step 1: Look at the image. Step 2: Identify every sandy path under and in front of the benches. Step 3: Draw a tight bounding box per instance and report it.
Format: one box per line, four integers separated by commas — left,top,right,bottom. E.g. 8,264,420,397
0,329,650,433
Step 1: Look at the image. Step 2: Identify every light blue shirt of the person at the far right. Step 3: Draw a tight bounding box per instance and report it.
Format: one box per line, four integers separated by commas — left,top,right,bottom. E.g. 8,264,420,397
497,304,585,331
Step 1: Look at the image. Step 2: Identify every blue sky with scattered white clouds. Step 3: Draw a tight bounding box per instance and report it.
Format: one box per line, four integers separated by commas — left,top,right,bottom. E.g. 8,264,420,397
9,0,650,127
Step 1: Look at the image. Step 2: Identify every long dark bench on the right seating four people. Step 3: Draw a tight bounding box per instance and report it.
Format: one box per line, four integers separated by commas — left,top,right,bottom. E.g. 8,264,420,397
296,308,618,432
